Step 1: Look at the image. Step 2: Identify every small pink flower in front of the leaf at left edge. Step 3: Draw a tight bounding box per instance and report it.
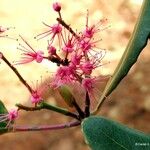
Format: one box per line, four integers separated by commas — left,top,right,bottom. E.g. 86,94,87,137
0,109,18,127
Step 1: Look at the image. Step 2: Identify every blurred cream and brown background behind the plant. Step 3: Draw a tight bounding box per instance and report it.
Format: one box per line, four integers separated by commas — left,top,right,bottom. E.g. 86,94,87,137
0,0,150,150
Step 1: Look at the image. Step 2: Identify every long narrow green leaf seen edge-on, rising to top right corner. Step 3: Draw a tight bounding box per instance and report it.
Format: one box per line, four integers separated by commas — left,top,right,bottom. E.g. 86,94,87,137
94,0,150,114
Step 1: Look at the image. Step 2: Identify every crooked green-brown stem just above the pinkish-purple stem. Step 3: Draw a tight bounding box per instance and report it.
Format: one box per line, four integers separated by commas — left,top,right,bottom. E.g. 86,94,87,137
16,102,80,120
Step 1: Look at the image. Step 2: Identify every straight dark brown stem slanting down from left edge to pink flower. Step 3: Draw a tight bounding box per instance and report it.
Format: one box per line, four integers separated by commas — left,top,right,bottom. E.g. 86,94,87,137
1,54,33,93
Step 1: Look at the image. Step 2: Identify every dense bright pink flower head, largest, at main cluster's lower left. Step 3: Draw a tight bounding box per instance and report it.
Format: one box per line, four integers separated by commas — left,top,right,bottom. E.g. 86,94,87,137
51,66,75,88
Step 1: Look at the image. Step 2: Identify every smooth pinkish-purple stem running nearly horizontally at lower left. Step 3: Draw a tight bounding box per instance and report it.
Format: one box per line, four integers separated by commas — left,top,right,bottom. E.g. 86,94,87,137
12,121,81,132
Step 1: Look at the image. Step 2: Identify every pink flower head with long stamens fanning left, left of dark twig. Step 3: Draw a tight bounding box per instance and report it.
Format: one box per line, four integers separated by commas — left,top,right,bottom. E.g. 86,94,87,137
16,36,44,64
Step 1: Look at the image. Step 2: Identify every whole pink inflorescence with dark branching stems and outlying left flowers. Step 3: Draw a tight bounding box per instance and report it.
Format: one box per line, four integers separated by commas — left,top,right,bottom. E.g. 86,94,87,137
0,2,108,123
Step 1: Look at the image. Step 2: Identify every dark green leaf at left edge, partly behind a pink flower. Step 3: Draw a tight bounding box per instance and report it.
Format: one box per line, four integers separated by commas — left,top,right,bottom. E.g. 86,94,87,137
0,100,8,134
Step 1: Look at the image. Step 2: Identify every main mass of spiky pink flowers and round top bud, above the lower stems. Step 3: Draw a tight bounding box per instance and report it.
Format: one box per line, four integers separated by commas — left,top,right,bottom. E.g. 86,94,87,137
16,2,107,106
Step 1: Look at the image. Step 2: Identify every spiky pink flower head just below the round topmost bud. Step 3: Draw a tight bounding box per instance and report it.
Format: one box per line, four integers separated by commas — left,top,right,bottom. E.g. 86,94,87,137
35,23,62,43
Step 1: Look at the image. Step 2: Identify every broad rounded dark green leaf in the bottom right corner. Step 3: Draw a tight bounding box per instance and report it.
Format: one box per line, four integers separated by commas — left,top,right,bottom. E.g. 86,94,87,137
82,116,150,150
